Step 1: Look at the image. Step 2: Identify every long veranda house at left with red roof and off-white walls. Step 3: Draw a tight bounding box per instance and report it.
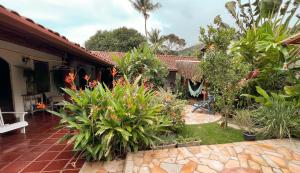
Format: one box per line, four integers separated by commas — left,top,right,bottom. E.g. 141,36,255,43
0,5,111,117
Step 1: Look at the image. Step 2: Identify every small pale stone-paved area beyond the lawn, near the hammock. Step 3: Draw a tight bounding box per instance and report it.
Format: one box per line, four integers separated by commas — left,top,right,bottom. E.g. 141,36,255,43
184,105,222,124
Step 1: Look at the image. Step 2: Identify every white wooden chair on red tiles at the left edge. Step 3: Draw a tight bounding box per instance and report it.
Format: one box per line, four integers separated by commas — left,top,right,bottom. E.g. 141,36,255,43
0,109,28,134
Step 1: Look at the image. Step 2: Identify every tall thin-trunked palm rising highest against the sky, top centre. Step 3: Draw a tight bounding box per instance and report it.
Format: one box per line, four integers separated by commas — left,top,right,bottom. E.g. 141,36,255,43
129,0,161,38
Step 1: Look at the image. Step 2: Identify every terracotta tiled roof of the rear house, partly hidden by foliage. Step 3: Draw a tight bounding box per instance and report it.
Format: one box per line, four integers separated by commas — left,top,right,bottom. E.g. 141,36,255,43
92,51,197,71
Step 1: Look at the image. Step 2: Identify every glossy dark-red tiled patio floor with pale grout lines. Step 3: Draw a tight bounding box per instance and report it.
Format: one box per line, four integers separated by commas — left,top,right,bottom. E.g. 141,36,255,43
0,113,84,173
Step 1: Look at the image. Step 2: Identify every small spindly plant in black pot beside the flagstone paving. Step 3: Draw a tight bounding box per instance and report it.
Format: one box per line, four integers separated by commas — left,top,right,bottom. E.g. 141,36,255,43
234,110,256,141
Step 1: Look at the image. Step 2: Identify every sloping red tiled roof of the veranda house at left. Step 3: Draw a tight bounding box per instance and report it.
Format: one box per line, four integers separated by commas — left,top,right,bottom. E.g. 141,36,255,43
0,5,111,65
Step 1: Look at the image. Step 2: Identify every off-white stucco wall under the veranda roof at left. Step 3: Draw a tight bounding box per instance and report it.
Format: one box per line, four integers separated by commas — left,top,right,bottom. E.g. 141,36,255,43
0,40,61,111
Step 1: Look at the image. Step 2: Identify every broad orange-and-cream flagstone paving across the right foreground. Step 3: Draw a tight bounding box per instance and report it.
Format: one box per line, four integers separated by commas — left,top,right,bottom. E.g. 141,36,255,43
124,139,300,173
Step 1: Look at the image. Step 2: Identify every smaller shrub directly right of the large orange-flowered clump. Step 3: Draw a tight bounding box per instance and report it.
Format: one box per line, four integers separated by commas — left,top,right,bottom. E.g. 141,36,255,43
152,88,186,132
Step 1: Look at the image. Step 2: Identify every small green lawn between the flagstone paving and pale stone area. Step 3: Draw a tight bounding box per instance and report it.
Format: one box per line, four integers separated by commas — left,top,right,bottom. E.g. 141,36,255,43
177,123,244,145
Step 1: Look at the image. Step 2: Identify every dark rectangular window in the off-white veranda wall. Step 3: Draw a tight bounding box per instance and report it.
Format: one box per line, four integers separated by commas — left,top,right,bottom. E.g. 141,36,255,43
34,61,50,93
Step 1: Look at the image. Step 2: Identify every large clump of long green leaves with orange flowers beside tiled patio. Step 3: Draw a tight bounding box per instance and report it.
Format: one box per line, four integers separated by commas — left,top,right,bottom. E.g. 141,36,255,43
50,75,171,160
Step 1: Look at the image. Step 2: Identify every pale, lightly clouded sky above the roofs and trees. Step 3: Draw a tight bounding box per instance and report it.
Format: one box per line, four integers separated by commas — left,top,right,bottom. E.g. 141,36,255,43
0,0,233,46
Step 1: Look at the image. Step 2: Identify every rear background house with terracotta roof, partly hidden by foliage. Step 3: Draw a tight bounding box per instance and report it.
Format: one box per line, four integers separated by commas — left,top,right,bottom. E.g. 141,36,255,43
92,51,197,88
